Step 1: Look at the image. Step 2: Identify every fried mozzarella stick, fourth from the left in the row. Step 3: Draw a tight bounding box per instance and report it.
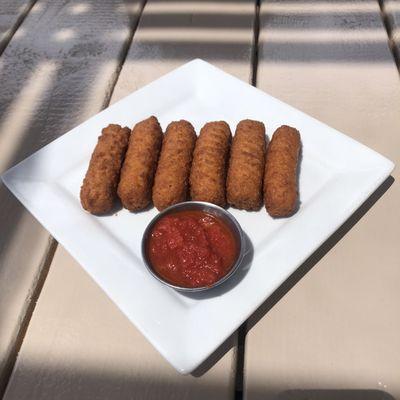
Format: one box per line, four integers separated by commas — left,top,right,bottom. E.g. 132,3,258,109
190,121,232,207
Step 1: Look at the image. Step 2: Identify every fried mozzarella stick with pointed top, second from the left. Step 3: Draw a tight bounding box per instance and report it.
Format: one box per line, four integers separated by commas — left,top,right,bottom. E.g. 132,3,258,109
118,117,163,211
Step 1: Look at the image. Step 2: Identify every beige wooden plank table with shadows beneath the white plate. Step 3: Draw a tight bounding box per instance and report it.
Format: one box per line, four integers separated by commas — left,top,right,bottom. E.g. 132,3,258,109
0,0,400,400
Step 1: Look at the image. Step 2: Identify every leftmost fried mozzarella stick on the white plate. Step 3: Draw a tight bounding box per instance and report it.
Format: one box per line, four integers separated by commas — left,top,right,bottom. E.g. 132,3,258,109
80,124,131,214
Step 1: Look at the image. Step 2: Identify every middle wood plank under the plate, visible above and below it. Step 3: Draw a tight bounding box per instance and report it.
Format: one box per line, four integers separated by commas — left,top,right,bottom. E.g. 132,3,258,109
5,1,254,400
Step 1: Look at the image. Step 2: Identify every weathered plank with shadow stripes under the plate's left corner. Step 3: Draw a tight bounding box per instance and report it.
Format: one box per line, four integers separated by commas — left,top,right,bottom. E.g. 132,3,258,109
0,0,144,391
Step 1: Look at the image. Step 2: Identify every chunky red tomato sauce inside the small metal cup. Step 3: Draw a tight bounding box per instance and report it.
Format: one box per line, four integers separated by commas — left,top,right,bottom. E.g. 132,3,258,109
147,211,239,288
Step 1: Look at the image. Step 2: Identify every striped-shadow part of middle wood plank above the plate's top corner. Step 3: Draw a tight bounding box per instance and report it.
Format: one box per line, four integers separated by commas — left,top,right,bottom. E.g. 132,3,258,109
111,0,255,97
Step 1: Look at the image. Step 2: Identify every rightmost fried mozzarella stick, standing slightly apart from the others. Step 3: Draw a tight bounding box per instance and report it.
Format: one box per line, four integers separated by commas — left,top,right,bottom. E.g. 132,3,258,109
264,125,301,217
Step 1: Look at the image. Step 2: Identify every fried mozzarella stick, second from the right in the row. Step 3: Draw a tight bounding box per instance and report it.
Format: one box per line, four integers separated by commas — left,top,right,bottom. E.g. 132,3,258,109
226,119,266,211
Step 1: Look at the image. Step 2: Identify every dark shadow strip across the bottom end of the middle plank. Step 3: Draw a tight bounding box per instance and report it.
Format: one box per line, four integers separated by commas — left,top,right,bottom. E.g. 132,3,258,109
4,357,234,400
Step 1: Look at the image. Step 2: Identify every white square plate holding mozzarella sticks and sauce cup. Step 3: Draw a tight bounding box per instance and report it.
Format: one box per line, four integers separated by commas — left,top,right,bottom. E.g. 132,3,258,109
3,60,394,373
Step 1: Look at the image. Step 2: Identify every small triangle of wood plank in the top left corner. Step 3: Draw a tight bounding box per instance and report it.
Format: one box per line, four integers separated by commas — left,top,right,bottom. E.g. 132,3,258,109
0,0,35,54
